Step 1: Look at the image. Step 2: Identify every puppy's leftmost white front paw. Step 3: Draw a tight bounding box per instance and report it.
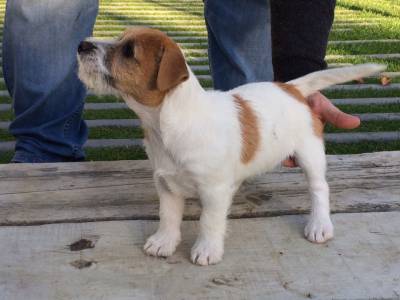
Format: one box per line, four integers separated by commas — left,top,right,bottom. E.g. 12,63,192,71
143,232,180,257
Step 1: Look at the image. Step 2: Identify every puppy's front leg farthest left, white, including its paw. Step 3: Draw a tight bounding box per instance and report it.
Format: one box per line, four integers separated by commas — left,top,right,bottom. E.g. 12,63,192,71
144,176,184,257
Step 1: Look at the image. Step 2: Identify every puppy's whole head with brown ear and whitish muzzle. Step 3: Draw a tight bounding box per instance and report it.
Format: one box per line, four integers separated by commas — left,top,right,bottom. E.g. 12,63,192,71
78,28,189,106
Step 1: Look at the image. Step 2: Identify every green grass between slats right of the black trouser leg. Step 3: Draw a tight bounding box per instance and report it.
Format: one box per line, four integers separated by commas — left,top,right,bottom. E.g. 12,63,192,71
324,0,400,159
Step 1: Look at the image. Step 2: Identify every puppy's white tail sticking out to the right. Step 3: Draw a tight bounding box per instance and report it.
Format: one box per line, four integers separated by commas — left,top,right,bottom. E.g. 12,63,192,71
287,64,386,97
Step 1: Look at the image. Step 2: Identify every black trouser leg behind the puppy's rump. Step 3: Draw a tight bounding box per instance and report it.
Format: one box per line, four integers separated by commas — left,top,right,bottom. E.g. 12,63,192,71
271,0,336,82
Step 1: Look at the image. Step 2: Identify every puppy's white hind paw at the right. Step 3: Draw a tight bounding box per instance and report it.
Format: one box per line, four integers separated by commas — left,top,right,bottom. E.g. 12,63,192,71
304,216,333,243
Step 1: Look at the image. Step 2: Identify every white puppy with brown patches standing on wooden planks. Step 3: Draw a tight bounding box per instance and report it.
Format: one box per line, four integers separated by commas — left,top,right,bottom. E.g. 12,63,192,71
78,27,384,265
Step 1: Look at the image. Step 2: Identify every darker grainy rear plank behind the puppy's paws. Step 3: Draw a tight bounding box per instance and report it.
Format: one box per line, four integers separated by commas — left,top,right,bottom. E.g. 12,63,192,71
0,151,400,225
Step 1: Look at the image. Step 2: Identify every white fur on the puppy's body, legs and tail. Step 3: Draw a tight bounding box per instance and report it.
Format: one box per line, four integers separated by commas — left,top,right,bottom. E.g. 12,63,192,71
76,42,379,265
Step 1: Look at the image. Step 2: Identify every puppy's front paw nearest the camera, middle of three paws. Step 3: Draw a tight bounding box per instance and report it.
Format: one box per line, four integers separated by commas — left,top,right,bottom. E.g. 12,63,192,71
191,239,224,266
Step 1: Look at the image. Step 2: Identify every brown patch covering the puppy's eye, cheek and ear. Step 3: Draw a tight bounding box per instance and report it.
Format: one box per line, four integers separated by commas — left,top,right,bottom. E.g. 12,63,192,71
106,27,189,106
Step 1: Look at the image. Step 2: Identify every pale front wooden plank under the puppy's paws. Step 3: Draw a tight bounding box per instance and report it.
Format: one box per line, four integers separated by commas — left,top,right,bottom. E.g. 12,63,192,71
0,212,400,300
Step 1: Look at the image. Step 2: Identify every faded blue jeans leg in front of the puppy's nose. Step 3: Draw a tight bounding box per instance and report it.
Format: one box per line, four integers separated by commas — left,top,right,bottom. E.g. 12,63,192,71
3,0,98,162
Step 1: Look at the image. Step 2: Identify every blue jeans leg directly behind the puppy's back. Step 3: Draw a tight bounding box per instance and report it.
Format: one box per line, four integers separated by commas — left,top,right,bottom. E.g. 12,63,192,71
204,0,274,90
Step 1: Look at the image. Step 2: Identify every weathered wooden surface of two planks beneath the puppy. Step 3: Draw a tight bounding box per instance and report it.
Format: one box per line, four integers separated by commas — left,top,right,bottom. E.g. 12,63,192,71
0,152,400,300
